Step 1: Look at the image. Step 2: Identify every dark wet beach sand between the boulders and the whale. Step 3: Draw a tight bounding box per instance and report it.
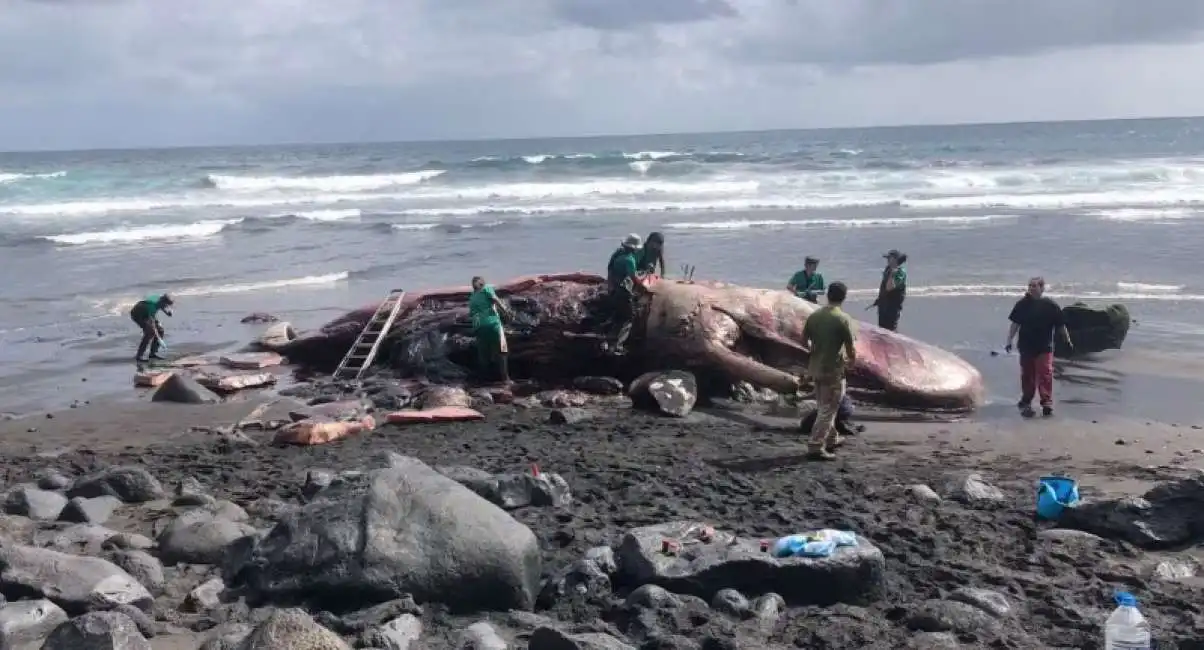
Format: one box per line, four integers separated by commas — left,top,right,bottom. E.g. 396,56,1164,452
0,397,1204,650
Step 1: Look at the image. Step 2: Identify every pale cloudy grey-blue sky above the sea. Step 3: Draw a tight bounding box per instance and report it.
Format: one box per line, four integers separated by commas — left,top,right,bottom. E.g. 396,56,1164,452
0,0,1204,150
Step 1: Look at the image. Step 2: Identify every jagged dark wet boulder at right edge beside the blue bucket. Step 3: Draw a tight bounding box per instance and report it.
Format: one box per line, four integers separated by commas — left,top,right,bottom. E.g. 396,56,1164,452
1058,471,1204,549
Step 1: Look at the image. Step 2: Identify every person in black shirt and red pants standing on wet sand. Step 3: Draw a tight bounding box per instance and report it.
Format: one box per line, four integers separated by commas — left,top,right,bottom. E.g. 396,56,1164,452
1004,277,1074,418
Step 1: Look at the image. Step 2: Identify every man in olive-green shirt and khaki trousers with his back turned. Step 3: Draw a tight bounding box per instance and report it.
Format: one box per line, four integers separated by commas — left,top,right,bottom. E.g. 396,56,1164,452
803,282,857,460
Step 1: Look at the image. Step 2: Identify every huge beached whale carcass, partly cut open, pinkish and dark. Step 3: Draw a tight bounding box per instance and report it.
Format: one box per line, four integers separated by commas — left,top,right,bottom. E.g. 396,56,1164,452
267,273,982,410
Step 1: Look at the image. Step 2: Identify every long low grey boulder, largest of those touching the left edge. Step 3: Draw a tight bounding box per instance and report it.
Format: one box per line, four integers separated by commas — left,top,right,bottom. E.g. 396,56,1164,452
0,544,153,614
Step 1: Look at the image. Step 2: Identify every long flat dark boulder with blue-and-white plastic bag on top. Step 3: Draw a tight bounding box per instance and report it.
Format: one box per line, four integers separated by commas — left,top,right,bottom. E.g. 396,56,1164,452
619,521,886,605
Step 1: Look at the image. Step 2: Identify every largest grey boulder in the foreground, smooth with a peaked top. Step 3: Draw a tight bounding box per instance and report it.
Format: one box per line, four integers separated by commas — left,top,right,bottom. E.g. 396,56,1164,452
242,454,539,611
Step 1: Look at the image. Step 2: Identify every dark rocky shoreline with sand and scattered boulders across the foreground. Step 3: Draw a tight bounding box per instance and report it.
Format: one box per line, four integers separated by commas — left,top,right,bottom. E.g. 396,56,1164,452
0,380,1204,650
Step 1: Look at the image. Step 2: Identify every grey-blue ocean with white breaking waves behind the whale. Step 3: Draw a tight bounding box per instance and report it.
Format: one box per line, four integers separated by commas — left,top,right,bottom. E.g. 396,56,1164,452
0,119,1204,421
